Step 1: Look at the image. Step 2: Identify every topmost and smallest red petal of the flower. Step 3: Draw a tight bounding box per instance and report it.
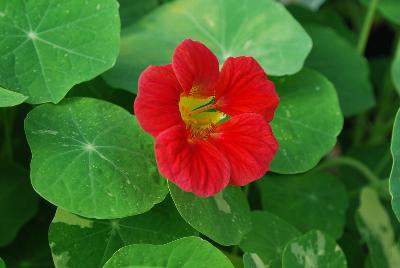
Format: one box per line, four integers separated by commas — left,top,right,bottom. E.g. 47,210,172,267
172,39,219,96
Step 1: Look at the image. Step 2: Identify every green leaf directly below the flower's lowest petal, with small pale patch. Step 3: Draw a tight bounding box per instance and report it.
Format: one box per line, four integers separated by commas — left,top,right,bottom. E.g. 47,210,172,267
168,183,251,246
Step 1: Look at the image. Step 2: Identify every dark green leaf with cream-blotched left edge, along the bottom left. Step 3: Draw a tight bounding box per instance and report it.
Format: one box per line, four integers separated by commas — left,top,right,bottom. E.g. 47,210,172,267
49,198,198,267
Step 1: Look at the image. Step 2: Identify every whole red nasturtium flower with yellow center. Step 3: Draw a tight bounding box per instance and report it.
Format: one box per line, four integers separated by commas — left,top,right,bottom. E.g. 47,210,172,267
134,39,279,196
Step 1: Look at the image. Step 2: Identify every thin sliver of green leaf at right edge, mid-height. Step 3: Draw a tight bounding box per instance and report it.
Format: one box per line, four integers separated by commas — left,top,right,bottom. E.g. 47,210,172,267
389,110,400,220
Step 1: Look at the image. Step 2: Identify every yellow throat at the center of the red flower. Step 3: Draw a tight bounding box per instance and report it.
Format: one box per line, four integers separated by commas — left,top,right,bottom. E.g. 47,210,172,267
179,95,225,139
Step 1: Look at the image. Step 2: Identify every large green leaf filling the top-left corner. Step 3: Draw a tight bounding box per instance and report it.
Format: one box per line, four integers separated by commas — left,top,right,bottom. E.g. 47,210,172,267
0,0,120,104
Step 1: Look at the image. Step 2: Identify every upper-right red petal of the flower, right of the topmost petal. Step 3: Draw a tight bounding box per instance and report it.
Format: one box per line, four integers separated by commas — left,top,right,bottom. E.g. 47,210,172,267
216,57,279,122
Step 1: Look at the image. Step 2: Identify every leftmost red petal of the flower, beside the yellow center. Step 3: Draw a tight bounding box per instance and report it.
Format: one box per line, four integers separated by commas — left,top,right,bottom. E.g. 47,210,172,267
134,64,184,137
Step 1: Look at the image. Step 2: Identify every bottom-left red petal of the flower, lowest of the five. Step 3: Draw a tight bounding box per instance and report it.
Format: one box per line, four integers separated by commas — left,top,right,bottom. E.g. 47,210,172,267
156,126,230,196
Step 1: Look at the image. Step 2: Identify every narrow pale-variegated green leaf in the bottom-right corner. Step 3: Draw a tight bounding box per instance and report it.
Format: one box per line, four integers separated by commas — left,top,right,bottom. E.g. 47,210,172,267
356,187,400,268
